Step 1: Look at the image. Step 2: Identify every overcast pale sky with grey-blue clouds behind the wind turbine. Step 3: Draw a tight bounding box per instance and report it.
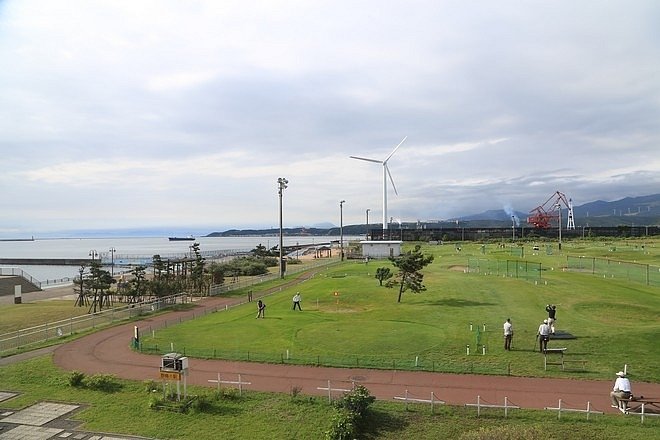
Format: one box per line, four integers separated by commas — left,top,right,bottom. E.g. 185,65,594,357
0,0,660,237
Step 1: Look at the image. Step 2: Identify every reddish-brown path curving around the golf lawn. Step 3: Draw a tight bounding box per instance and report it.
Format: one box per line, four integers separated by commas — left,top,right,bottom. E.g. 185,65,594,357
20,272,660,412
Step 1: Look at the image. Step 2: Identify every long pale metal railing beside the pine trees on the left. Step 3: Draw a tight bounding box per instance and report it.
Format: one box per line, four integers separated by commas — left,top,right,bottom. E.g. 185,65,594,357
0,293,190,354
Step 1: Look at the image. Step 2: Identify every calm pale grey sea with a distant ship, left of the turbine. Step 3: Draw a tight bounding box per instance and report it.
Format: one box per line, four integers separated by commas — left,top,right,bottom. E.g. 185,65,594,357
0,236,364,282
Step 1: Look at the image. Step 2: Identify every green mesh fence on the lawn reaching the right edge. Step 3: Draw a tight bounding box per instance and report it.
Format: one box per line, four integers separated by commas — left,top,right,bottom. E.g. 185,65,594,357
566,255,660,287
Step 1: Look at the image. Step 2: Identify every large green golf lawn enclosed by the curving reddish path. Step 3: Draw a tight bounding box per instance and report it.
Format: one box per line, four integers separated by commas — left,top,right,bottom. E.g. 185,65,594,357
142,240,660,382
